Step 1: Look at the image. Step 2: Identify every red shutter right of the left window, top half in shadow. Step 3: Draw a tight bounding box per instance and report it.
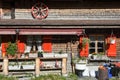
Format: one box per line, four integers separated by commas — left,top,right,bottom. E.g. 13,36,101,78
42,36,52,53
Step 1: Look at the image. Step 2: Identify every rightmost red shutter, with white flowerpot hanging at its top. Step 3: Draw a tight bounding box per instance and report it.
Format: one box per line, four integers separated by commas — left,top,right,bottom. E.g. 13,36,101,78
107,36,116,57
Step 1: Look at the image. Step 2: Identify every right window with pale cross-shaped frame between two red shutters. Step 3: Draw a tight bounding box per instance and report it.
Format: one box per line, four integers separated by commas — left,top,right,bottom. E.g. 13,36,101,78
89,35,105,54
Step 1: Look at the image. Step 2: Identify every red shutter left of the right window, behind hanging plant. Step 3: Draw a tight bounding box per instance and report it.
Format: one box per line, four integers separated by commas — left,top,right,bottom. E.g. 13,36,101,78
80,36,89,57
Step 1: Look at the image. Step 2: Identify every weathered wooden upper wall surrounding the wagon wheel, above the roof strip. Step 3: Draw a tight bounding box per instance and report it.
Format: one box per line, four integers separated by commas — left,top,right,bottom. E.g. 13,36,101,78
2,0,120,20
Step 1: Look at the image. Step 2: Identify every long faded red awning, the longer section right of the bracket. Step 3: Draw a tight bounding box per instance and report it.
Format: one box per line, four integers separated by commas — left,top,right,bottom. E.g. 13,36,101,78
19,28,82,35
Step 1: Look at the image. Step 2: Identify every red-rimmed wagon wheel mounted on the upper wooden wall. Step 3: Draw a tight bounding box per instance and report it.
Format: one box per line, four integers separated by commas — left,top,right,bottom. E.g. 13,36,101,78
32,3,48,19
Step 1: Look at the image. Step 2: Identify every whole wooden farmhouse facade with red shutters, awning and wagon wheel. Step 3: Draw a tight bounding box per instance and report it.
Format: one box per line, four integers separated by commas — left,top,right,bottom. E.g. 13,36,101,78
0,0,120,63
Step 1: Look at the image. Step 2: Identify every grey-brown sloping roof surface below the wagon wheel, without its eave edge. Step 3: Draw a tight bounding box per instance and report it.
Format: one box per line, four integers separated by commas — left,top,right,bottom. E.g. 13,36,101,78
0,19,120,26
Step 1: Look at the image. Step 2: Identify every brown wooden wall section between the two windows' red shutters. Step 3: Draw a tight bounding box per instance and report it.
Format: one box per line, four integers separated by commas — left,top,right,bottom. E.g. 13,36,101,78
52,35,79,53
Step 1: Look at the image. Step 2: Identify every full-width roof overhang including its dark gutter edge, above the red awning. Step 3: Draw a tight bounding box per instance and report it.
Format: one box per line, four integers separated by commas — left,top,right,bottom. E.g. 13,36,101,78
0,19,120,28
